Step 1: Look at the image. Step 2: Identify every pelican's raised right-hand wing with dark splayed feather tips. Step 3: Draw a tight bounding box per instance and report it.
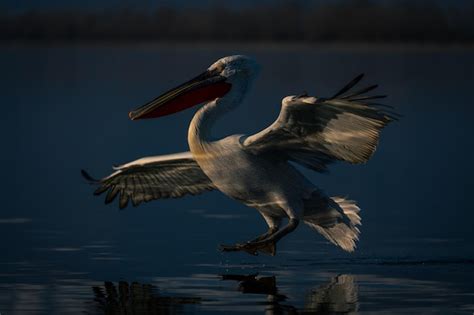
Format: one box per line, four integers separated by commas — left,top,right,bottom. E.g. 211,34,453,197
243,74,397,172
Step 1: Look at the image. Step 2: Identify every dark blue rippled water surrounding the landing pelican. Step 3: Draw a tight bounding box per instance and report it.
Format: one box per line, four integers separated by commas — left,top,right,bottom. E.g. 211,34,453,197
0,44,474,314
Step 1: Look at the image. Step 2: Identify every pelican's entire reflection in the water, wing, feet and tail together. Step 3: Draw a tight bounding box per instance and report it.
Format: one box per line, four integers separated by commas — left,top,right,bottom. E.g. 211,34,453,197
87,274,358,315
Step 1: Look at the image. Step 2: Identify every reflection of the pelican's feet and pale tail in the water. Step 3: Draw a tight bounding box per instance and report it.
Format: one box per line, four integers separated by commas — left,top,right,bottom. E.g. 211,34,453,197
222,274,358,314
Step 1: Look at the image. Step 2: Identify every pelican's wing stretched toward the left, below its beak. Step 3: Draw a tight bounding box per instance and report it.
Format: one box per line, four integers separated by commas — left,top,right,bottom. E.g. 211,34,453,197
82,152,215,209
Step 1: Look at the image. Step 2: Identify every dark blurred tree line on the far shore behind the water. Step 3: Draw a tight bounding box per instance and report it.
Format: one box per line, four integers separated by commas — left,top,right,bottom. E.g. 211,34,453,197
0,0,474,43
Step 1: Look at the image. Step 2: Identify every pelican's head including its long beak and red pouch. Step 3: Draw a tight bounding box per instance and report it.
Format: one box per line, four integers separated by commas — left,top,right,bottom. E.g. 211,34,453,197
129,55,260,120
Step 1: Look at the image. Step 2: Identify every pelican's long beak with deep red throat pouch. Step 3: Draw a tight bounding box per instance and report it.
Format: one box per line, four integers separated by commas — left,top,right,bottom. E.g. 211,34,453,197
128,70,232,120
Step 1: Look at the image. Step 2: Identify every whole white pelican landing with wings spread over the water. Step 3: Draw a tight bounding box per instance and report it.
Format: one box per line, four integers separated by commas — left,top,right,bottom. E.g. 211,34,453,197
82,55,397,255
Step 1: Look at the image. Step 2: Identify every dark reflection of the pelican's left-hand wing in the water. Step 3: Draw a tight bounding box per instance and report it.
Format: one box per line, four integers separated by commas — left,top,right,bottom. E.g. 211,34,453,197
92,281,201,314
